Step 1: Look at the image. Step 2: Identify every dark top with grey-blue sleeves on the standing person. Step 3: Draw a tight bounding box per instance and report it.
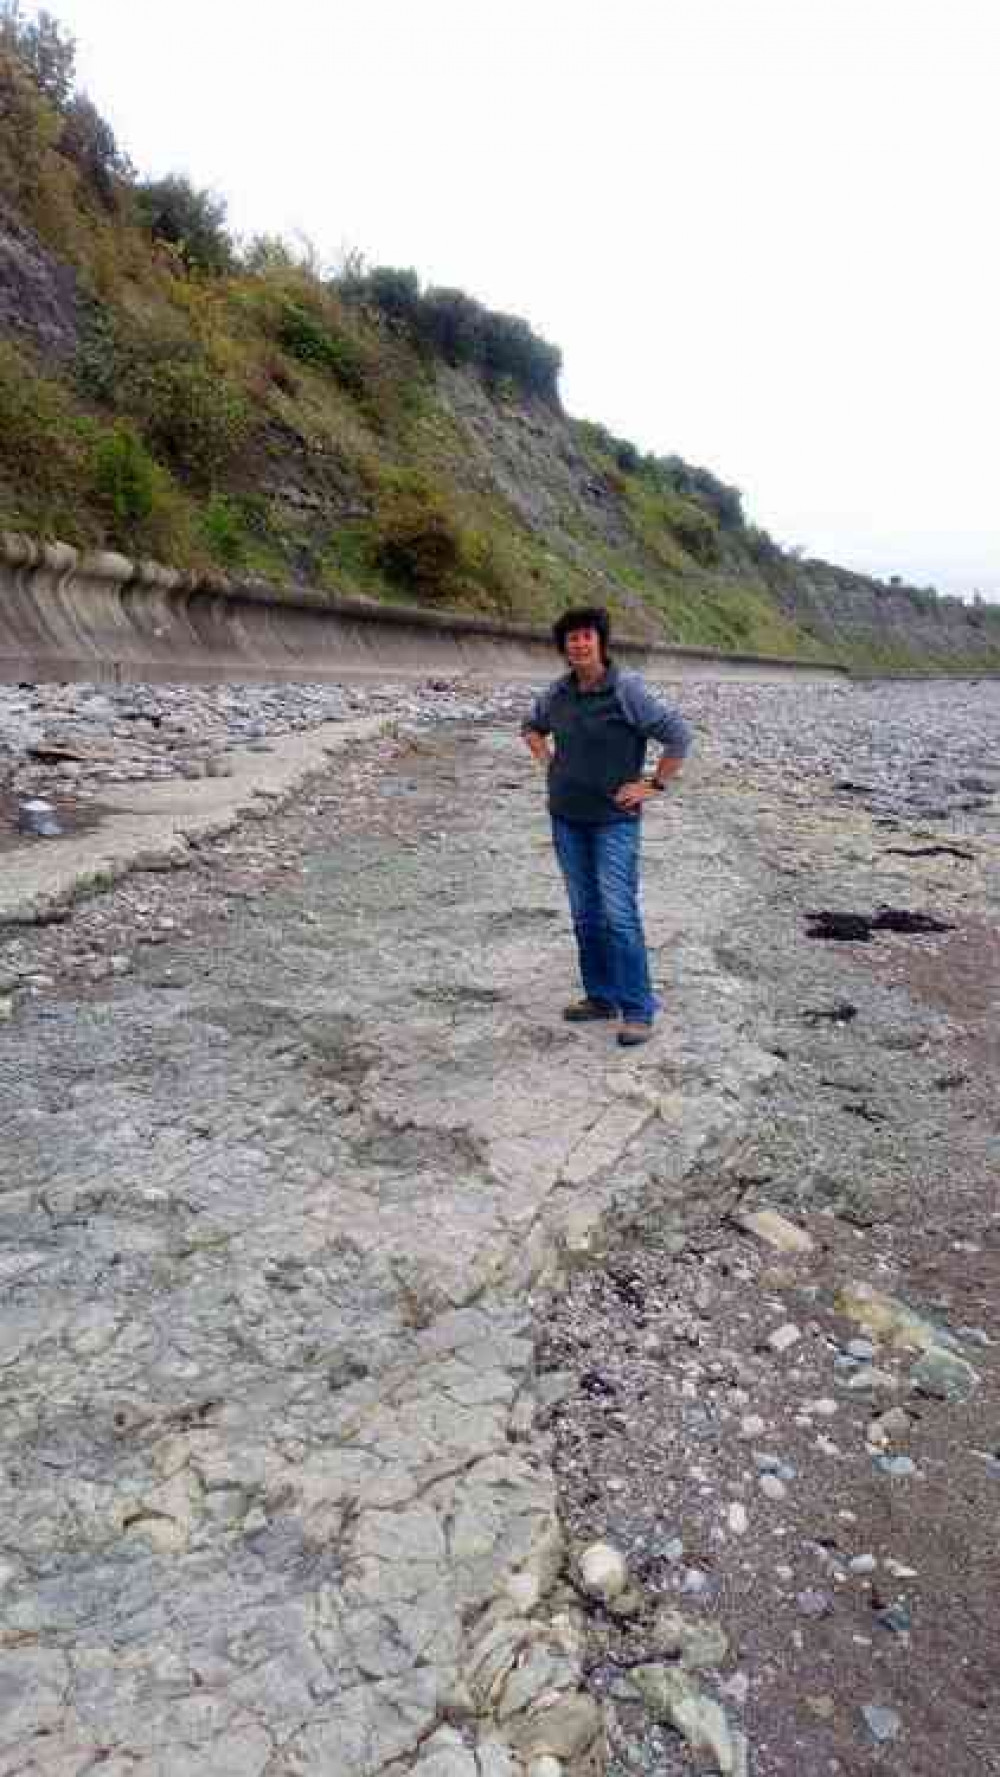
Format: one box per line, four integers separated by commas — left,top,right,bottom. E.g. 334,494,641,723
522,665,691,825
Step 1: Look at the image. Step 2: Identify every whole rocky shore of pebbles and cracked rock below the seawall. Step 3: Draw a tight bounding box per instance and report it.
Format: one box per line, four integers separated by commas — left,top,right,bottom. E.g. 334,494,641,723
0,682,1000,1777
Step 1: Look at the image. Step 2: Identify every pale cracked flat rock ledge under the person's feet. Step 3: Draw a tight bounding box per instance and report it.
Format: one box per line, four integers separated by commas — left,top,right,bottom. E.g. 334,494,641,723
0,700,774,1777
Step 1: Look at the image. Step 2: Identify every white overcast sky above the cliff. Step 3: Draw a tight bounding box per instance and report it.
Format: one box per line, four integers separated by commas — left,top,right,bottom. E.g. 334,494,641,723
56,0,1000,599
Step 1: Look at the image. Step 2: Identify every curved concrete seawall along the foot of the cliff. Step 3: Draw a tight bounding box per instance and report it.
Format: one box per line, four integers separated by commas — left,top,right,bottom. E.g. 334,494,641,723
0,531,847,684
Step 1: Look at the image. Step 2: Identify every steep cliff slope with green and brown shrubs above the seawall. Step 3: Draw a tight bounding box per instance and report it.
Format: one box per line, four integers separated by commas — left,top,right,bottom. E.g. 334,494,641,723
0,0,1000,666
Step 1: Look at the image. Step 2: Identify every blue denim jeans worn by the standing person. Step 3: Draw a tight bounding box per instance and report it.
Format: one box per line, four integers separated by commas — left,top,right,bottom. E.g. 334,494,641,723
552,814,657,1024
